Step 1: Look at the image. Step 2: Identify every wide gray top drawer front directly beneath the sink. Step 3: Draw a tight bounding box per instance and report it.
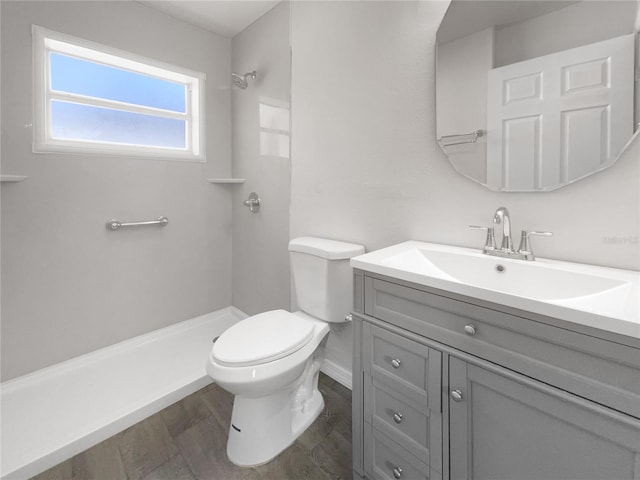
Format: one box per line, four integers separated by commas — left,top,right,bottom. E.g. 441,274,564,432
365,277,640,418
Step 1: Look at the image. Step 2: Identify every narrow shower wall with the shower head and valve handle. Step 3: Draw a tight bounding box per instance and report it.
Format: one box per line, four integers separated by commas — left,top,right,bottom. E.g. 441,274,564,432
230,2,291,315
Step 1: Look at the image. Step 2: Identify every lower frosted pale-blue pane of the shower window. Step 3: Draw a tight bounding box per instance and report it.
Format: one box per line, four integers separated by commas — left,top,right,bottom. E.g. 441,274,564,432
51,100,186,149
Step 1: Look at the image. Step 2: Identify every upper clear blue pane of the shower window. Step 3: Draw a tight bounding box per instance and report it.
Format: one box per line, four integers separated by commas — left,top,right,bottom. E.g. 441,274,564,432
50,52,186,113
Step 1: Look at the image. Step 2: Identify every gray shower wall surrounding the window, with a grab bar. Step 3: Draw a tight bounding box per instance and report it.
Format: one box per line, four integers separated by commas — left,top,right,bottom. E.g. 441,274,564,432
1,1,231,380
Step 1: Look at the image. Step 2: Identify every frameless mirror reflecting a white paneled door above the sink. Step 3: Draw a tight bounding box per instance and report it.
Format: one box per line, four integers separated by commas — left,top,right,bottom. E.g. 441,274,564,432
436,0,640,192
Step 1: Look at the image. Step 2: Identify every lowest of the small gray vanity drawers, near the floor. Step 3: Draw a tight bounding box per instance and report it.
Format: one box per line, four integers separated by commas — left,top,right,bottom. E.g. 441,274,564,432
364,423,441,480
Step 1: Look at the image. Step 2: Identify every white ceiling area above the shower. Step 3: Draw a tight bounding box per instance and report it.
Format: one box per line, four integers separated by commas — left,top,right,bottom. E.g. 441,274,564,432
137,0,280,37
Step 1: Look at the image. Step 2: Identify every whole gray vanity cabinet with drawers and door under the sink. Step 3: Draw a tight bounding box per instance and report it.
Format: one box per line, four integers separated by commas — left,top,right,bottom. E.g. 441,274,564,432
353,270,640,480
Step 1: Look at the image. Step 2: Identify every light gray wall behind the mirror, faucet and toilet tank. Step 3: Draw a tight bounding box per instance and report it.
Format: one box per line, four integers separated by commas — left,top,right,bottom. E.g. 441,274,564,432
290,1,640,376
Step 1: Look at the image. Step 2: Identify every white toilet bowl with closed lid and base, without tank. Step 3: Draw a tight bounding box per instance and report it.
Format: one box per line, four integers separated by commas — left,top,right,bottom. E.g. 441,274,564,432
207,310,329,466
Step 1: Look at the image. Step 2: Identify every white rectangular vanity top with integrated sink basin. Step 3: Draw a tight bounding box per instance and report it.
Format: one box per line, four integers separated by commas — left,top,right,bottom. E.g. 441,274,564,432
351,241,640,338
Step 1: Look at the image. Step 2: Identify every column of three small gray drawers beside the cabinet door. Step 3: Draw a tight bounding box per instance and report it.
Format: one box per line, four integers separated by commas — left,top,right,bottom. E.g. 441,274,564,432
363,324,442,480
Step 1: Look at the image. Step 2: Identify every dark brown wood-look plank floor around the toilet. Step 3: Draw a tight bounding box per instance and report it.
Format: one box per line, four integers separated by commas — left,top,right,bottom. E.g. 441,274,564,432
32,374,352,480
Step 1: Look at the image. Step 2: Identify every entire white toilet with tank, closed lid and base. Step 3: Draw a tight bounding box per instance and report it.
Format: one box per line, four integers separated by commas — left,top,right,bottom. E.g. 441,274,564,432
207,237,364,466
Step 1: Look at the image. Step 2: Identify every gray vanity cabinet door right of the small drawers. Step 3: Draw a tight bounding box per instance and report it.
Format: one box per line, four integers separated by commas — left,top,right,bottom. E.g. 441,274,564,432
449,357,640,480
